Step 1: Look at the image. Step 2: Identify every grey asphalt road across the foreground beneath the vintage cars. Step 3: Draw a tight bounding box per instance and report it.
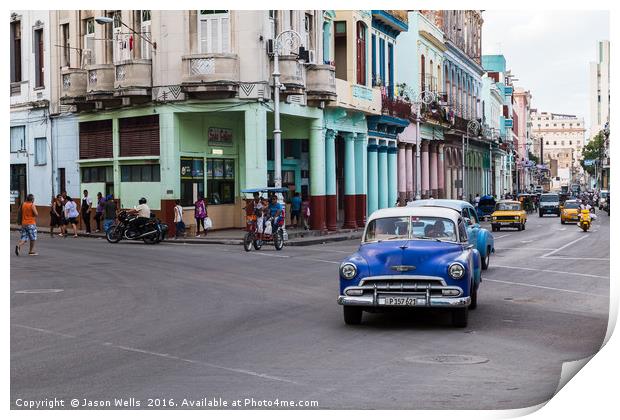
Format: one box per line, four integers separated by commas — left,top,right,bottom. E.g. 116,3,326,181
11,212,609,409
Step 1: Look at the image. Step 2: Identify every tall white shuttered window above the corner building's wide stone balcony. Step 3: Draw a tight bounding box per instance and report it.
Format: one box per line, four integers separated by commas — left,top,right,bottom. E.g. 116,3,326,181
198,10,230,53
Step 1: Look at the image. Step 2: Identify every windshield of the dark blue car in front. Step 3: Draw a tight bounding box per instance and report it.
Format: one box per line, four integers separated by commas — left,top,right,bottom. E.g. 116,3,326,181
364,216,456,242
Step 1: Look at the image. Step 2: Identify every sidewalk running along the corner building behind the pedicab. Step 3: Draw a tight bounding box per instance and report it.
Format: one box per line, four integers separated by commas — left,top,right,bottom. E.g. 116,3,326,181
10,224,364,246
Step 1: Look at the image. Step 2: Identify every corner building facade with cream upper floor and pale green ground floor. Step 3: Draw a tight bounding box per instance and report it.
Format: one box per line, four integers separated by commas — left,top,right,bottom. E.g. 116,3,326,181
51,10,336,228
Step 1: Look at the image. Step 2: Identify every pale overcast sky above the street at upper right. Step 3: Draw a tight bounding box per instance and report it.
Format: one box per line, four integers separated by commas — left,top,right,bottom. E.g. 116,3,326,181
482,10,609,134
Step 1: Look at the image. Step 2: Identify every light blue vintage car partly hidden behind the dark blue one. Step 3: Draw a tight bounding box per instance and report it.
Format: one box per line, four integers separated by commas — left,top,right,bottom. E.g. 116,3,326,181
407,200,495,270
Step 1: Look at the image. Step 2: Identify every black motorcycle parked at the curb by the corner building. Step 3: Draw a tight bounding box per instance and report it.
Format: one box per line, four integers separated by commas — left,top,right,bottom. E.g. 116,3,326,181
106,210,168,244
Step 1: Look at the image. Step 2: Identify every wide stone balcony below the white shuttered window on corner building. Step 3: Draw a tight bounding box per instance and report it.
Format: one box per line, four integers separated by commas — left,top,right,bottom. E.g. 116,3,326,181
181,53,239,98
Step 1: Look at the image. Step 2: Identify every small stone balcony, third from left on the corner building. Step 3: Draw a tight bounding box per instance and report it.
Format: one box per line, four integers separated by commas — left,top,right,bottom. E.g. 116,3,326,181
114,58,153,104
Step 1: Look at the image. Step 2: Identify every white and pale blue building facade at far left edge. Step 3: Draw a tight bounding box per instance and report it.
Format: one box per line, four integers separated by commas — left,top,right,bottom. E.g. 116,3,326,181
10,10,55,222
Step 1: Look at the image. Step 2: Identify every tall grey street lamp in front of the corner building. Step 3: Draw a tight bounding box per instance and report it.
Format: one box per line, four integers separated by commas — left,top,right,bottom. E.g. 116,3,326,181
272,29,302,188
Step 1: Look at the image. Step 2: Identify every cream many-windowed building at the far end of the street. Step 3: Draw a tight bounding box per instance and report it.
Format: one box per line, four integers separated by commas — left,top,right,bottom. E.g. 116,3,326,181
530,109,586,188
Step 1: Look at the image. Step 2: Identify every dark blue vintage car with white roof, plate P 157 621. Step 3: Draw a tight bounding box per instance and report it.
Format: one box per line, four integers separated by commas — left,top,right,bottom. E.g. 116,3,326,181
338,207,481,327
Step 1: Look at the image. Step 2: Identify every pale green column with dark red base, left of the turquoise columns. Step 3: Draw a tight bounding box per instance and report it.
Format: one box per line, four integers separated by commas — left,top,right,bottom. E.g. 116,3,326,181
310,118,326,230
